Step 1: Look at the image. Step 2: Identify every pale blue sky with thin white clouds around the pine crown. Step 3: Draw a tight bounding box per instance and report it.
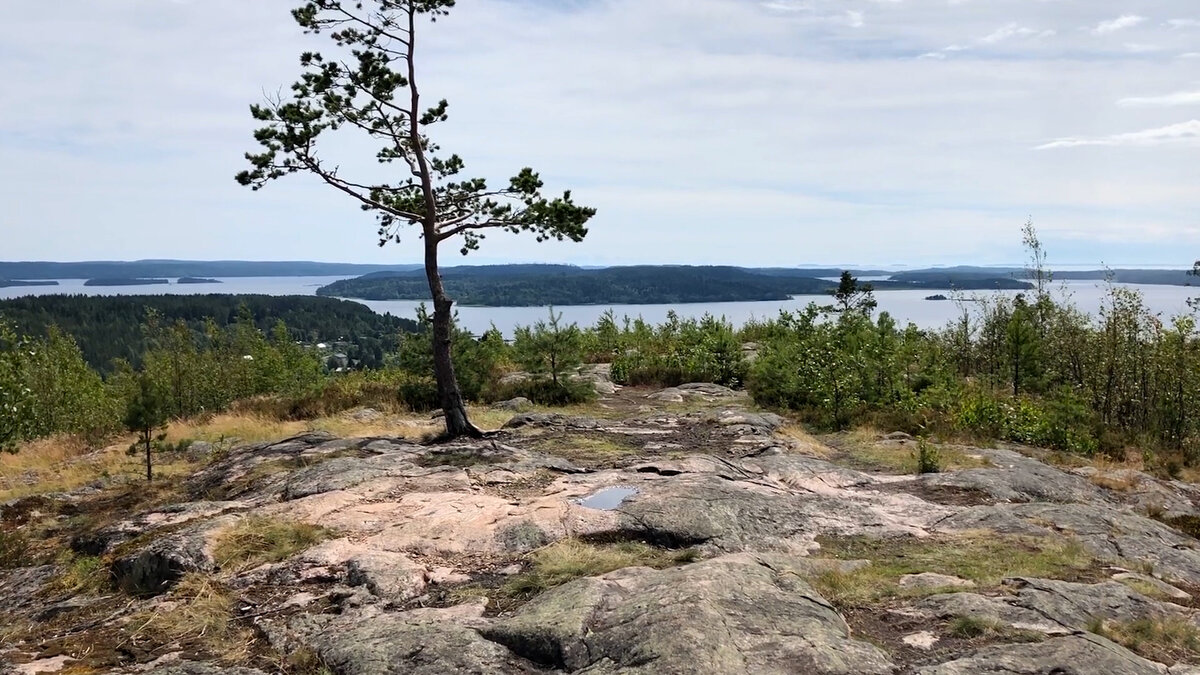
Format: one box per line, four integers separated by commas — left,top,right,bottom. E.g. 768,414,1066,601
0,0,1200,267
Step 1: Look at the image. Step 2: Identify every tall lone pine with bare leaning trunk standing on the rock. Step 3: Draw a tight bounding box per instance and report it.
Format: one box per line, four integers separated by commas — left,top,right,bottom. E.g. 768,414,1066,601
238,0,595,437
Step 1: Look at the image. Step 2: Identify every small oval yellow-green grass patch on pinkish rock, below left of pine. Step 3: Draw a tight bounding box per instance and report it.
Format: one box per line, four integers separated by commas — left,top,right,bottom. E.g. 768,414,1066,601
212,516,335,573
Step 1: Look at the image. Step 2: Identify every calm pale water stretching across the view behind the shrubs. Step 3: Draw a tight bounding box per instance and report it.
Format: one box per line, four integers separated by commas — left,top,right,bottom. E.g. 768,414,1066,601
0,276,1200,334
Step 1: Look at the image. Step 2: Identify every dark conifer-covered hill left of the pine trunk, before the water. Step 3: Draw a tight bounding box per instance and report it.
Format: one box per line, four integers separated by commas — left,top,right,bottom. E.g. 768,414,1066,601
0,294,418,374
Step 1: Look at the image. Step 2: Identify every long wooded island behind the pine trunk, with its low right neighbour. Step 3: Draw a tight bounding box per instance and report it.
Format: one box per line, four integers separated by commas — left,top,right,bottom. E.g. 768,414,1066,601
317,265,1032,306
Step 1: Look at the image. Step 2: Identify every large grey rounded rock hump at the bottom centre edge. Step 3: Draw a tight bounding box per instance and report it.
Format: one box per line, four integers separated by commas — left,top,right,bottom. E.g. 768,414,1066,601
480,555,894,675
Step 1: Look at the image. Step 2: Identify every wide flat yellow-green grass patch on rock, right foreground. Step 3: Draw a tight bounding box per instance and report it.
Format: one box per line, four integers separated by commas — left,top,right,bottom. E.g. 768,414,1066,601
812,533,1094,607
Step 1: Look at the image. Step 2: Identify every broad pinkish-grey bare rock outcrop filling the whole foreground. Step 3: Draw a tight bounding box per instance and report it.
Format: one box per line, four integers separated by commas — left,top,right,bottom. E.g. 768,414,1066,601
7,381,1200,675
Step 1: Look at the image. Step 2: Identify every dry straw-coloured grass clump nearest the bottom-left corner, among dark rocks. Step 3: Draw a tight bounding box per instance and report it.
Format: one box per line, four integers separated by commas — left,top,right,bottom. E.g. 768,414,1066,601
128,574,254,663
